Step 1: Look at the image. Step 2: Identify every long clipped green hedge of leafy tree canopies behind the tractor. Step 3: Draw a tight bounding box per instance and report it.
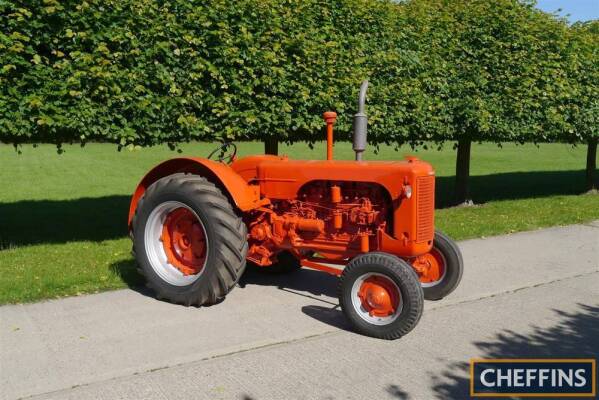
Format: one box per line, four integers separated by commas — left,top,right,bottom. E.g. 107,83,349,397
0,0,596,150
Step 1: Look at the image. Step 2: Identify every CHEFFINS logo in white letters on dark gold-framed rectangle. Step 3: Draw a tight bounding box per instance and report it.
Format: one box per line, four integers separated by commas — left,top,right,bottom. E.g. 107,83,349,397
470,358,597,397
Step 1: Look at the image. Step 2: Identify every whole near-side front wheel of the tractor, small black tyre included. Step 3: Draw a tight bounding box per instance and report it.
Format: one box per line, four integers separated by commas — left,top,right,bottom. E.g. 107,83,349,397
339,252,424,340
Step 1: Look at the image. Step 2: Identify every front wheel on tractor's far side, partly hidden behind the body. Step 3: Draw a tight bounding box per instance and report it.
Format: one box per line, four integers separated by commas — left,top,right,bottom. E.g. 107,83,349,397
411,231,464,300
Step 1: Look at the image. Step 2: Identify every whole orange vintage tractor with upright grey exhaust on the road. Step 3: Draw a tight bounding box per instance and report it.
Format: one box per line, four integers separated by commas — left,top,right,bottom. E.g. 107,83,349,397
129,81,463,339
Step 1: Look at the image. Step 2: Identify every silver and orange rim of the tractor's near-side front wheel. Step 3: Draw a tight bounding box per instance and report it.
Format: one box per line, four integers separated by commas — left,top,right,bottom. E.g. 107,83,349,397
351,272,403,325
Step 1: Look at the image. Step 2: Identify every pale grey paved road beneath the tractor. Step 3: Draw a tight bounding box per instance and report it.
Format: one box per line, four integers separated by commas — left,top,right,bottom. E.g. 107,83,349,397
0,221,599,400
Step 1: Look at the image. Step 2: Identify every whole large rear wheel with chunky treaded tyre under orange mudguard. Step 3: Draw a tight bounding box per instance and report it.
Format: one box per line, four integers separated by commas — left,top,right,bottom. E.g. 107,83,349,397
132,173,247,306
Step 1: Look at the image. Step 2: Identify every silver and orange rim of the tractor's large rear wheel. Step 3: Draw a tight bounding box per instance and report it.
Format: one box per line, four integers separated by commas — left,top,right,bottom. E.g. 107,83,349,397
144,201,208,286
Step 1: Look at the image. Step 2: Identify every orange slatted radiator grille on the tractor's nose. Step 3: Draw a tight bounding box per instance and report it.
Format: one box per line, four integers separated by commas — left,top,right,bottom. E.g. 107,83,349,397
416,176,435,243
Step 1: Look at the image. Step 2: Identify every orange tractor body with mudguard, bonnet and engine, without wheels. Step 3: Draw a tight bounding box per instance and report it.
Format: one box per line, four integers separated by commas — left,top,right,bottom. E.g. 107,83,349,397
129,148,435,273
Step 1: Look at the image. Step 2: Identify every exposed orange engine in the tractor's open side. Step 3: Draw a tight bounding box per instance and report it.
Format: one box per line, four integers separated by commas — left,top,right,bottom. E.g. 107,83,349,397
247,180,392,266
